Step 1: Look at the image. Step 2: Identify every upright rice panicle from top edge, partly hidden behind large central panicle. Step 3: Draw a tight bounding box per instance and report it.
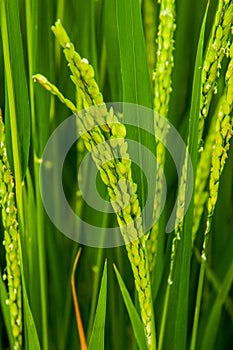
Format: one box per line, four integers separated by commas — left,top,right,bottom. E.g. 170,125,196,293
147,0,176,273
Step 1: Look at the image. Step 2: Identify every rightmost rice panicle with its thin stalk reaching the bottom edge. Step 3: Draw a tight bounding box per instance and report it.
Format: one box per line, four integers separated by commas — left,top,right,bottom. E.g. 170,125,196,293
191,39,233,350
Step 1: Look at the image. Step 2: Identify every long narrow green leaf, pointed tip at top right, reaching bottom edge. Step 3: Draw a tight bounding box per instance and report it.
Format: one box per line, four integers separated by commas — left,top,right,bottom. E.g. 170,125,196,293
174,6,208,350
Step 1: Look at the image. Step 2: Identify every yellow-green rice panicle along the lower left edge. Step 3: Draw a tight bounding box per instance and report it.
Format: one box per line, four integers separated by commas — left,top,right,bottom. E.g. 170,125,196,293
0,114,22,350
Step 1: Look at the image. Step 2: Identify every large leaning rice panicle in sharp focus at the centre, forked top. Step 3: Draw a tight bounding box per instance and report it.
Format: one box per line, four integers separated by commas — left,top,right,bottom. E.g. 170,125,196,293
34,21,155,349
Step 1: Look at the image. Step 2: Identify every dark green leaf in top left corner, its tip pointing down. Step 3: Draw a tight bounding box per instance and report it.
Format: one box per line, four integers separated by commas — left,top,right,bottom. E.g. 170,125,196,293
2,0,30,178
